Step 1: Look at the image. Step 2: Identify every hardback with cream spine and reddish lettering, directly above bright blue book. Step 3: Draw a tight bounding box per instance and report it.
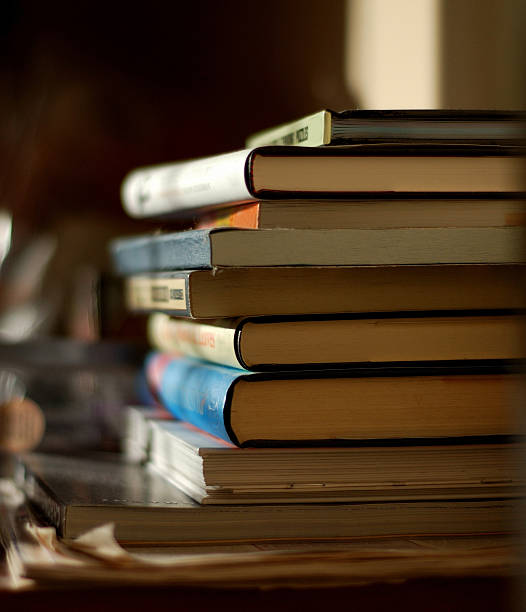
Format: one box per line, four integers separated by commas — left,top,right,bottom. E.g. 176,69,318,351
148,311,525,371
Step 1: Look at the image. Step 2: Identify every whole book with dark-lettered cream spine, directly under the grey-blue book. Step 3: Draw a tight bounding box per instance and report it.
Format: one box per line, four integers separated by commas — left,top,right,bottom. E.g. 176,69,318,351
125,265,525,319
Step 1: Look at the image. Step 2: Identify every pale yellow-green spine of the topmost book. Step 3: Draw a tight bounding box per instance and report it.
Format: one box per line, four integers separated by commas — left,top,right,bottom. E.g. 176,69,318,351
246,111,331,148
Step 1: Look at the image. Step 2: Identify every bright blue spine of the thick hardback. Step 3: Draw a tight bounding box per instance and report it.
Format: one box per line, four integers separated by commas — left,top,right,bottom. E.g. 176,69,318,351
146,353,241,444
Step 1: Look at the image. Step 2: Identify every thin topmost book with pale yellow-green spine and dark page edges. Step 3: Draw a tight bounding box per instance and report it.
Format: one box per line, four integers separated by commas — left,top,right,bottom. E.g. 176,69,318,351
246,109,524,147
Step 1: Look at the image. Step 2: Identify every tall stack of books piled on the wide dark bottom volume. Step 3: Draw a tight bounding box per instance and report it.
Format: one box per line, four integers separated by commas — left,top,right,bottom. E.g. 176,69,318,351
111,111,526,537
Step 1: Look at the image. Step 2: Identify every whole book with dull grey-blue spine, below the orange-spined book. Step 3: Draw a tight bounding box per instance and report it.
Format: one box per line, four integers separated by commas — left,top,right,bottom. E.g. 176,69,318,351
110,227,525,275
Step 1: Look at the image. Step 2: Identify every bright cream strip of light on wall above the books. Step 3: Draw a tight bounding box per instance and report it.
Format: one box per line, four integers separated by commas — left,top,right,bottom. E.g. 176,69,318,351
346,0,441,109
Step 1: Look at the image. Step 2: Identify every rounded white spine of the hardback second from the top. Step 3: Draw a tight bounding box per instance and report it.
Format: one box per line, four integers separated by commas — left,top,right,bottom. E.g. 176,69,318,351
121,151,253,218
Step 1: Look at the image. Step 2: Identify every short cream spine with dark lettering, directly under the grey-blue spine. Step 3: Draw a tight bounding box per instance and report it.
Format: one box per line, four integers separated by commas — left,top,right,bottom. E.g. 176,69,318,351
125,274,191,316
